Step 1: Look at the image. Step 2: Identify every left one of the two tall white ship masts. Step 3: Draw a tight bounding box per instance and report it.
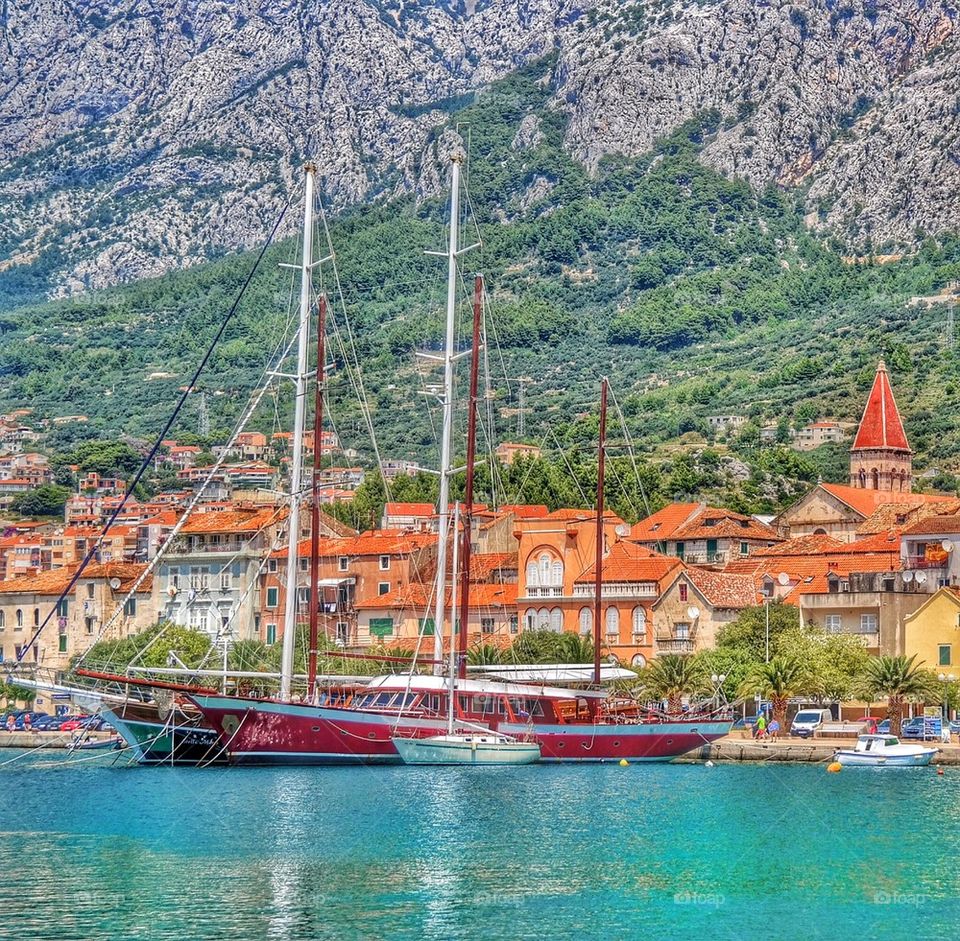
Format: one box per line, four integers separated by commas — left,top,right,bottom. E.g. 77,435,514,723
280,163,317,700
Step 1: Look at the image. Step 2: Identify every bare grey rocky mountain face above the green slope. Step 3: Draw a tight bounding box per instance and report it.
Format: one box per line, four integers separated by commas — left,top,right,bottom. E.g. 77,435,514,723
0,0,960,307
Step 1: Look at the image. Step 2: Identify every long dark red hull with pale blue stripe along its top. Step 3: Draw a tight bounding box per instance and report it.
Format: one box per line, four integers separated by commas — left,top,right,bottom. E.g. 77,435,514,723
191,694,730,765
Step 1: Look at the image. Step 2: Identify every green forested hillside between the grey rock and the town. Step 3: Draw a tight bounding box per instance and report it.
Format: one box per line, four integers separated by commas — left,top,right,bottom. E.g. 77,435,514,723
0,57,960,507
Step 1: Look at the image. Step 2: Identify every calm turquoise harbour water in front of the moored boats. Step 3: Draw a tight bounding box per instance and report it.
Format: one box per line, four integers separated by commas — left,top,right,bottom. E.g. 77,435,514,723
0,752,960,941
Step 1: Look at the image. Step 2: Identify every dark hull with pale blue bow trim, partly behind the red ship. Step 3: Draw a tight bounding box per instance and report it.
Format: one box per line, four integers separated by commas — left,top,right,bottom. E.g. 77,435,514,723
103,703,227,765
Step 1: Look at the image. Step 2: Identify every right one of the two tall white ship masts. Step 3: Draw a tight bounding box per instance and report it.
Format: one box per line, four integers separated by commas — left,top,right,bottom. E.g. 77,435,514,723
433,153,463,674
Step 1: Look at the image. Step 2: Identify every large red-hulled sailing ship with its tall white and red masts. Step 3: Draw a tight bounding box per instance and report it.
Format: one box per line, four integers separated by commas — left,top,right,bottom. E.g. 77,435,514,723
190,156,730,765
